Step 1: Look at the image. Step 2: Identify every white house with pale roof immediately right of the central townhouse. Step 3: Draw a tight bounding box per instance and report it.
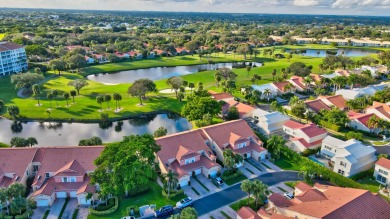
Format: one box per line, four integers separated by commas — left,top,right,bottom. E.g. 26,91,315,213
251,109,290,135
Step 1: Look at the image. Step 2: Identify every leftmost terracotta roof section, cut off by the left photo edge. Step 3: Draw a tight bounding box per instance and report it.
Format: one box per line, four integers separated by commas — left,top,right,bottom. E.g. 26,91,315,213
0,148,37,187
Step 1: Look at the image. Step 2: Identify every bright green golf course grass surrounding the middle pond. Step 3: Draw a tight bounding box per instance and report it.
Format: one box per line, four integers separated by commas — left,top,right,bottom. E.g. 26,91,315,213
0,47,378,122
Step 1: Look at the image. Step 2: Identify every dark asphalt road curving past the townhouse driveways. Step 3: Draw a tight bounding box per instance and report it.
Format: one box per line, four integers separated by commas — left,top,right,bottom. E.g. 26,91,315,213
149,171,301,218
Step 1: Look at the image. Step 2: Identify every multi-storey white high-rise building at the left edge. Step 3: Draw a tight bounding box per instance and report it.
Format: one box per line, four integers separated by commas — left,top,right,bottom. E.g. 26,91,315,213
0,42,28,77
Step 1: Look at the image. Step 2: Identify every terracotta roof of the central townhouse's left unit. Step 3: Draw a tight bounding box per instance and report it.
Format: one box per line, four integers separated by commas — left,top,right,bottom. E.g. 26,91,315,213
156,129,214,169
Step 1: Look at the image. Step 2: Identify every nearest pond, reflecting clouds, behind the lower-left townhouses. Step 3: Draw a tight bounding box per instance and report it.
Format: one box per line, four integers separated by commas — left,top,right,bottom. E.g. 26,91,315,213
0,114,192,146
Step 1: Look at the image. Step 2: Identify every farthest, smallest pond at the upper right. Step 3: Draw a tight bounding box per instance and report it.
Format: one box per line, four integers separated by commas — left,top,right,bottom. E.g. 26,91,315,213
286,49,379,57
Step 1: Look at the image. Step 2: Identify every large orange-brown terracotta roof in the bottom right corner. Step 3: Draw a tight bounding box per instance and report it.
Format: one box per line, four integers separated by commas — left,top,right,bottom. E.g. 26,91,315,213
285,186,390,219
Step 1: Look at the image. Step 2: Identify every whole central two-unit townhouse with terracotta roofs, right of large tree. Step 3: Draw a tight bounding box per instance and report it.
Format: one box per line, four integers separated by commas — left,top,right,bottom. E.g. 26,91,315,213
156,120,267,187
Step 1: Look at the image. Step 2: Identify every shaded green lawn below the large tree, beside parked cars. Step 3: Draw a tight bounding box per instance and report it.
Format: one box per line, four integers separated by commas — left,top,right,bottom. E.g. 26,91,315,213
88,182,184,219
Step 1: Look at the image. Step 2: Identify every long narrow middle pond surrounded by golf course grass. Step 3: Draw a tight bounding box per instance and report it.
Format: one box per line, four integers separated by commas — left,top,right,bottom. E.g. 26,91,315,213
87,62,262,85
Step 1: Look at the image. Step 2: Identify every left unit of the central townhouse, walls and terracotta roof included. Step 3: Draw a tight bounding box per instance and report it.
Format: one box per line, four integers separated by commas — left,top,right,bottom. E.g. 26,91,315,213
156,129,221,187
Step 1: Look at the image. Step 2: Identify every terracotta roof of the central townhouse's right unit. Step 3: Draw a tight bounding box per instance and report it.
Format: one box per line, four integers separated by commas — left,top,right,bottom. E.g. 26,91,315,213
203,119,262,148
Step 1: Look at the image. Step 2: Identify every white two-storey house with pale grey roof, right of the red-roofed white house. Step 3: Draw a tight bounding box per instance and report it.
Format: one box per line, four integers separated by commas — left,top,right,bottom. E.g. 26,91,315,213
321,136,377,177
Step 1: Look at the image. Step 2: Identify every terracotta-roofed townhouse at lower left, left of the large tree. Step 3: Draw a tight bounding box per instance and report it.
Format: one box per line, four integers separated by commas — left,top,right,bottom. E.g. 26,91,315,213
0,146,104,206
